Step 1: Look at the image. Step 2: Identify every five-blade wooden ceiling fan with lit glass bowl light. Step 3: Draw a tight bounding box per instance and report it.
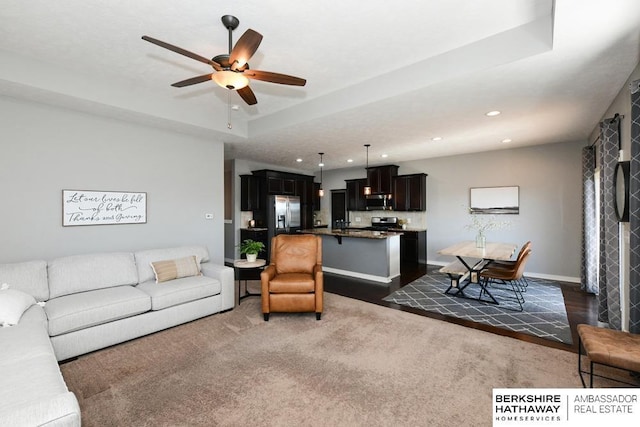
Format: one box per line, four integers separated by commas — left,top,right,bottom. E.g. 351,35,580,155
142,15,307,105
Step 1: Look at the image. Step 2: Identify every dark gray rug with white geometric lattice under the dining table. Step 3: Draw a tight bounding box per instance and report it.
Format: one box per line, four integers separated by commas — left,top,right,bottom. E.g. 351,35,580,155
384,274,572,344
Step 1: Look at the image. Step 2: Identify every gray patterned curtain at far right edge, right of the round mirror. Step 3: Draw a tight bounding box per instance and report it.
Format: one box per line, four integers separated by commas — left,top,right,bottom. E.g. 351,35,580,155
629,80,640,334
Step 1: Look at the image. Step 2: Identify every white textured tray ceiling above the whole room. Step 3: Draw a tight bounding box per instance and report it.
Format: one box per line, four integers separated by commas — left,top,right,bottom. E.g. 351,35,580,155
0,0,640,171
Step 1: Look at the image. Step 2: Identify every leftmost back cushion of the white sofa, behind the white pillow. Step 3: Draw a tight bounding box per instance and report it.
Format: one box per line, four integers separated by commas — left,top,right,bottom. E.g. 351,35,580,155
0,261,49,301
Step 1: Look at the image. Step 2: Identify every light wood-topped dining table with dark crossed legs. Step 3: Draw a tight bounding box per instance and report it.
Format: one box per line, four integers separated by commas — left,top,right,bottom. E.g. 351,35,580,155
438,240,518,305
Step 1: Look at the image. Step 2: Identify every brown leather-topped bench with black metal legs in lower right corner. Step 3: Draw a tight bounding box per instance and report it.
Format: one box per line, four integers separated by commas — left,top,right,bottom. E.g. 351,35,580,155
578,325,640,388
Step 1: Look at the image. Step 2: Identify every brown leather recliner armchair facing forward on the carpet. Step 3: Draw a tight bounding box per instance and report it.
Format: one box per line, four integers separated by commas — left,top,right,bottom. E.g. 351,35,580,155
260,234,324,321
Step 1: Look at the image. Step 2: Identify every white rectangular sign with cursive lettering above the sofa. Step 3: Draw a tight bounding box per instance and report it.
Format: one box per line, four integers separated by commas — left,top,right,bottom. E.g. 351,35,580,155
62,190,147,227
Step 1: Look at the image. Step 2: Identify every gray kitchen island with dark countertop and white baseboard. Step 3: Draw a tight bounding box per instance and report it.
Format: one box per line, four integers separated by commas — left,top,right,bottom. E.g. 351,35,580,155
300,228,402,283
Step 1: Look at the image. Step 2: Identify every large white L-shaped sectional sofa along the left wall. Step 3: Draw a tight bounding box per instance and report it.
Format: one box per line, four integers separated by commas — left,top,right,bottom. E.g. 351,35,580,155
0,246,235,426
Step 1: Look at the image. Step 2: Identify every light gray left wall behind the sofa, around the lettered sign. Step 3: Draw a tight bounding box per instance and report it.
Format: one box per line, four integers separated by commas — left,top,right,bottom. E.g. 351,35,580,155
0,96,224,263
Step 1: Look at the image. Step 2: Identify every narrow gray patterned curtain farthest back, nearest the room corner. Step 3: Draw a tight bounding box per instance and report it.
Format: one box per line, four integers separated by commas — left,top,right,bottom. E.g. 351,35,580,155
580,146,598,294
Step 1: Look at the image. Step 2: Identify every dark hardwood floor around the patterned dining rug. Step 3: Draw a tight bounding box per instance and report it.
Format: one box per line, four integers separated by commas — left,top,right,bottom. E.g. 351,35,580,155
324,264,598,353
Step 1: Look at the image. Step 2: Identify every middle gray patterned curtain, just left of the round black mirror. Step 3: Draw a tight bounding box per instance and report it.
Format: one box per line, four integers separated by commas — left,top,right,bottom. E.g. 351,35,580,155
598,116,622,330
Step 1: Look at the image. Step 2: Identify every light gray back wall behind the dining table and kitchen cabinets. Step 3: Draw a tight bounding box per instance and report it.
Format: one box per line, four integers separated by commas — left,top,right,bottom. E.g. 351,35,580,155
322,141,586,281
